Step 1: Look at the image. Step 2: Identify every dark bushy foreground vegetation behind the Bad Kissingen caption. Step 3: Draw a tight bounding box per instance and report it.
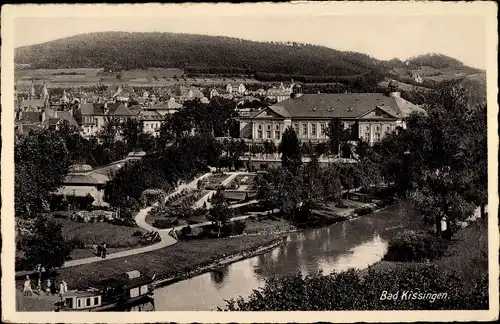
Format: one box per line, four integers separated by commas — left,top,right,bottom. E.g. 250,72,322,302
226,266,488,311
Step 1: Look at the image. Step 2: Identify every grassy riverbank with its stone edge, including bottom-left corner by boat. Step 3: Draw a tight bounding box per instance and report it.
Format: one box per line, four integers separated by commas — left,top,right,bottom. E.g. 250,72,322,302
16,235,283,311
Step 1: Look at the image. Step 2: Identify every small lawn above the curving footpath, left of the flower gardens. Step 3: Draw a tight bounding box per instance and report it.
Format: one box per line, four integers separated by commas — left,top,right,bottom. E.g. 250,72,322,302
54,218,146,252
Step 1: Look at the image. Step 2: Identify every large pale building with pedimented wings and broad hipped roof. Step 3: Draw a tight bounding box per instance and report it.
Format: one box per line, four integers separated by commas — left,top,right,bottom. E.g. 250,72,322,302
240,81,423,144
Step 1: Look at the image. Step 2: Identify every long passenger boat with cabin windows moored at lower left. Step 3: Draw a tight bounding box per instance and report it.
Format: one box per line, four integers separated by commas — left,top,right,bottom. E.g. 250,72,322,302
54,270,155,312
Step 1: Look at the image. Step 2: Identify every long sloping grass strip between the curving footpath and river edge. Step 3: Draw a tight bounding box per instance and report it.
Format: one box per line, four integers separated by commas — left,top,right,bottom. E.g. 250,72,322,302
59,235,278,289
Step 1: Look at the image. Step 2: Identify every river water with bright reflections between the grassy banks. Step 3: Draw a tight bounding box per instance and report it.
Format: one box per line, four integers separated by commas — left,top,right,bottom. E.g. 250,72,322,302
136,203,421,311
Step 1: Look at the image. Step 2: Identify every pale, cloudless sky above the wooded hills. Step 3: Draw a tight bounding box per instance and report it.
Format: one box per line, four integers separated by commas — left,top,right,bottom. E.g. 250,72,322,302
14,5,487,69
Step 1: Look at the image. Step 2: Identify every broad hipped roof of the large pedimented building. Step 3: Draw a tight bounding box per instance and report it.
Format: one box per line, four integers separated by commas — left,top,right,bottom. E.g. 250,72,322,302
258,93,422,119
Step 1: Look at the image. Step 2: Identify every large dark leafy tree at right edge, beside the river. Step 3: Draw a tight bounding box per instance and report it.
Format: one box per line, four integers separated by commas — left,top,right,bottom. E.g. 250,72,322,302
377,80,487,233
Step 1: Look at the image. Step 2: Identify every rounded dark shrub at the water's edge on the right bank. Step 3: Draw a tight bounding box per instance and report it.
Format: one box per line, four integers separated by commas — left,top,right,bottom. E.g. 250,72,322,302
384,231,449,262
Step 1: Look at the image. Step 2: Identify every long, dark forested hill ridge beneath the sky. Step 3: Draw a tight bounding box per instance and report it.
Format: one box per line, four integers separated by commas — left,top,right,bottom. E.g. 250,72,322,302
15,32,380,76
